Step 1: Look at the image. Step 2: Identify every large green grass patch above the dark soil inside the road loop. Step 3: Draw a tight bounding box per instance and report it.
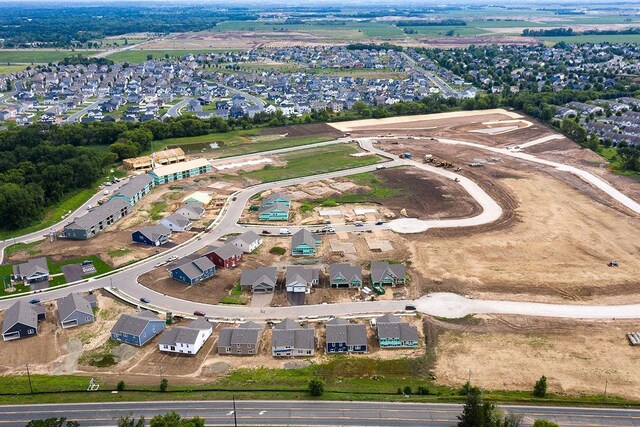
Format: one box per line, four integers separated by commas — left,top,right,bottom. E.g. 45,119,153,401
242,145,380,182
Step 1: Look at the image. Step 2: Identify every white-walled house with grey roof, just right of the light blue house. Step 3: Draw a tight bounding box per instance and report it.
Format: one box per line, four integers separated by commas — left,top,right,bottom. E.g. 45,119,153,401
158,318,215,355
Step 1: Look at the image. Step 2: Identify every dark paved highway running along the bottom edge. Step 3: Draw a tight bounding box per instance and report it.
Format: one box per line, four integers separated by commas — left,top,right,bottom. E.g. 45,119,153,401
0,400,640,427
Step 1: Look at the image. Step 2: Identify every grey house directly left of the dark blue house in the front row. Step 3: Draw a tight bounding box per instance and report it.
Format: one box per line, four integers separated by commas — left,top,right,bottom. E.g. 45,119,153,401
271,319,316,357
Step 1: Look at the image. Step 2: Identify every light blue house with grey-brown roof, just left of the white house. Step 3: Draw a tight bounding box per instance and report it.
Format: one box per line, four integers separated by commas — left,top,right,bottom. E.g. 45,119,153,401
111,310,165,347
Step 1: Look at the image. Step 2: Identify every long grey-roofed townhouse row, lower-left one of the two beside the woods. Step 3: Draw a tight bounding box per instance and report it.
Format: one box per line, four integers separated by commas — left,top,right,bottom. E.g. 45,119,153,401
62,199,131,240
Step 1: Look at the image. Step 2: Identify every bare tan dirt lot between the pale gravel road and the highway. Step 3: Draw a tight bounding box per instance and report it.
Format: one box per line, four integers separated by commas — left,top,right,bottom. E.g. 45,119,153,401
436,316,640,398
